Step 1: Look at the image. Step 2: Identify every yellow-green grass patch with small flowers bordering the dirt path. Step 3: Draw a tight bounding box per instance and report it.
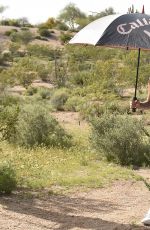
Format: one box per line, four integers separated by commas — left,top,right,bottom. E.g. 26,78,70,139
0,142,141,189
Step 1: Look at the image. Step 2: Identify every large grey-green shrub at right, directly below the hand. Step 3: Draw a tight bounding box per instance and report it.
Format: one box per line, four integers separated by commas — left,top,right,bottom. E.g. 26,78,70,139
91,114,150,166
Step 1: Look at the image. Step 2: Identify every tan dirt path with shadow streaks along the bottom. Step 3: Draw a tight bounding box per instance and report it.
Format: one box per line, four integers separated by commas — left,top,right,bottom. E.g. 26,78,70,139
0,182,150,230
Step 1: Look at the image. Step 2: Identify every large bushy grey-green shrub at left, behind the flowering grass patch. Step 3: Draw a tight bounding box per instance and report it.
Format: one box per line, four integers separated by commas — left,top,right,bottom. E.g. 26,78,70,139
15,104,71,148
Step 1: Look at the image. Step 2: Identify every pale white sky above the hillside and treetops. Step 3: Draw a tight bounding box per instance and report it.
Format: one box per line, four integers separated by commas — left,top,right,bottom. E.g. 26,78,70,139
0,0,150,24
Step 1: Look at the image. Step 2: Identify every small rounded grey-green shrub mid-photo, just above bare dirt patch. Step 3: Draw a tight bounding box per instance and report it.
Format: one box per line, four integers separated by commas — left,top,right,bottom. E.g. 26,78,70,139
51,88,69,111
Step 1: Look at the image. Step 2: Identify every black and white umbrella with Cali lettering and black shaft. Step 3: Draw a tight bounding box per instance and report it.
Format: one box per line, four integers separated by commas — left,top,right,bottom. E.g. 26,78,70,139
69,13,150,111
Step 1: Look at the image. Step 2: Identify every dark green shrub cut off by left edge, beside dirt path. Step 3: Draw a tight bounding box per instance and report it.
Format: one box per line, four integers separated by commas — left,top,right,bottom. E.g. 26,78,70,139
0,164,17,195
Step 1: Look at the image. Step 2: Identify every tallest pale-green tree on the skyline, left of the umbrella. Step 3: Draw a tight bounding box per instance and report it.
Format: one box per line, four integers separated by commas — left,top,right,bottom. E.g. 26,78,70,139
58,3,86,30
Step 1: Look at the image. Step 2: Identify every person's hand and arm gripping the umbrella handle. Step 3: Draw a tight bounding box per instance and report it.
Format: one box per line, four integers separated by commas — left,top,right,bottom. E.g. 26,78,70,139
130,79,150,109
